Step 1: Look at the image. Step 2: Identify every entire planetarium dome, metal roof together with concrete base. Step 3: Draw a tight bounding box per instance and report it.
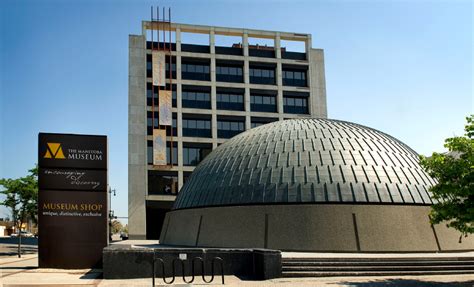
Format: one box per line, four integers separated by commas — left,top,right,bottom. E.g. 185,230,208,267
160,119,474,252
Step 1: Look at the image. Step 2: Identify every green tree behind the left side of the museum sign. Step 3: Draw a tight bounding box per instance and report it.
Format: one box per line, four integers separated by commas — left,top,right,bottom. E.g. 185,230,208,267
0,167,38,236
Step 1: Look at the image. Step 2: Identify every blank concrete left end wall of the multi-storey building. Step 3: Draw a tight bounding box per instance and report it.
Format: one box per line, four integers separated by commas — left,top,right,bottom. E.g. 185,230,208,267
128,35,147,239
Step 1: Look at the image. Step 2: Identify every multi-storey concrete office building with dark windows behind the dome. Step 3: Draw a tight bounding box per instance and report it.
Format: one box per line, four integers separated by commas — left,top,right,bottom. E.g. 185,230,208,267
128,21,327,239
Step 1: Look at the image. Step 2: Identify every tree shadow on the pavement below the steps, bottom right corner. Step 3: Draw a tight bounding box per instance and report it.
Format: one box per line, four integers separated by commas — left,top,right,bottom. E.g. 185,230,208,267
337,279,474,287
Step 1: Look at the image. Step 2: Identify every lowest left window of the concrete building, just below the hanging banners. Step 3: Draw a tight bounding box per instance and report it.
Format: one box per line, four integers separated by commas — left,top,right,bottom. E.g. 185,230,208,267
148,170,178,195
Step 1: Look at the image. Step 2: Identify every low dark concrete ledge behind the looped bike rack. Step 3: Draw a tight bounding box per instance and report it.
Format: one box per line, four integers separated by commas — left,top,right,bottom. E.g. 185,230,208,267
103,244,281,280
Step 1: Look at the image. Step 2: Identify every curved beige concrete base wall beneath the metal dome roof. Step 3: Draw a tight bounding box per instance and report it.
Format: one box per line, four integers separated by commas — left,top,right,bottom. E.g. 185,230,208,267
160,204,474,252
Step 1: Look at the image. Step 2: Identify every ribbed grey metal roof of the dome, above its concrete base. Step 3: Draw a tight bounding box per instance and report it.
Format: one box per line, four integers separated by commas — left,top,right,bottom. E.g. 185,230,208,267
174,119,435,209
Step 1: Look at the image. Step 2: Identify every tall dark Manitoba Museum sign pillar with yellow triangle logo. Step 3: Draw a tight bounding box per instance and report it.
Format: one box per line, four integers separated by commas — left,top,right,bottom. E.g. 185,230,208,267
38,133,108,269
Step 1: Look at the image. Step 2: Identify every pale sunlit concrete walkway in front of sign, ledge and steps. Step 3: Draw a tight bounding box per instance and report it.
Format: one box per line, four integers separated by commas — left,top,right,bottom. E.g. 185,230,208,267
0,249,474,287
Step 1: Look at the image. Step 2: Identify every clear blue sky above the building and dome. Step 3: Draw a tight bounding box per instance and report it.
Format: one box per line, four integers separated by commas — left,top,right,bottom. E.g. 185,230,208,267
0,0,474,222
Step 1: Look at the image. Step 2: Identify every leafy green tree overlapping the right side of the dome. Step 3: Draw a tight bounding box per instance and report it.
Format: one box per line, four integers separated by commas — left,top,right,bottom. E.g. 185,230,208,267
420,115,474,241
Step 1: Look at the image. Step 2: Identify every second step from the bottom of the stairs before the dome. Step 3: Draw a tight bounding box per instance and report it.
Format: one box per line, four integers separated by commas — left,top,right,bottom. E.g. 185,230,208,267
282,265,474,272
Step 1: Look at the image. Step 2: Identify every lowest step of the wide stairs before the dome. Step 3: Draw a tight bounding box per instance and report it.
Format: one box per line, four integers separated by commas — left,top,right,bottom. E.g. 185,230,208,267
282,270,474,277
